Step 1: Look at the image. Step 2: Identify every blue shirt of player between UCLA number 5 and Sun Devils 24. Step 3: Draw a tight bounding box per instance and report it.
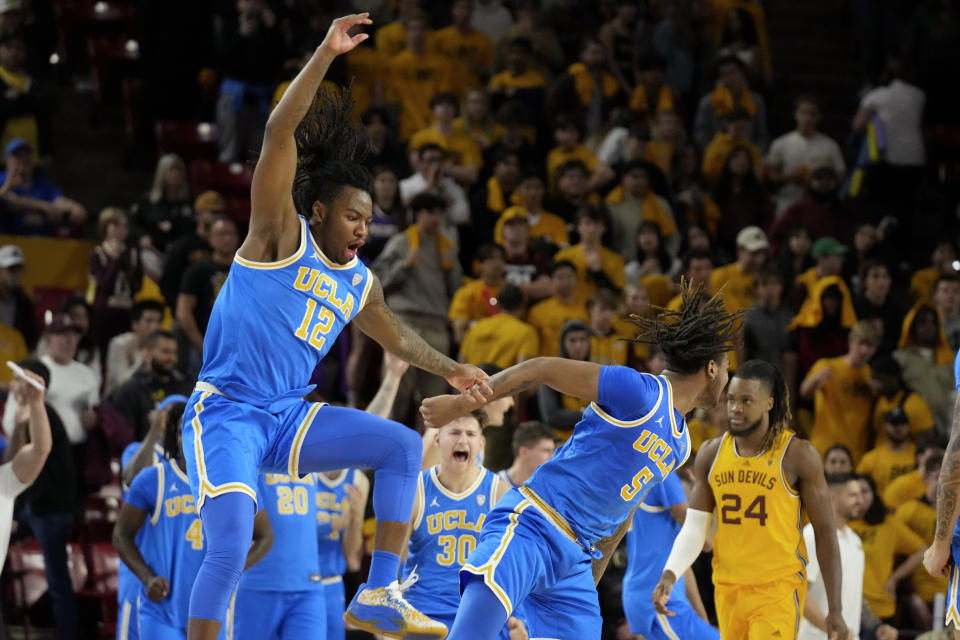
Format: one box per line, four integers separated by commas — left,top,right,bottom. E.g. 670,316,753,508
623,473,687,616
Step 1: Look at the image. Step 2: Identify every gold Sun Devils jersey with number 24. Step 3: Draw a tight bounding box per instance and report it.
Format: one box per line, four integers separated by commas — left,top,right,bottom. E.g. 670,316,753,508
709,431,807,585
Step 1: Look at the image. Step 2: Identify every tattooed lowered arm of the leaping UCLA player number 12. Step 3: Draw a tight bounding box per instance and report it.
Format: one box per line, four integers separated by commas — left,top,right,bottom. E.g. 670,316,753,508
353,275,490,398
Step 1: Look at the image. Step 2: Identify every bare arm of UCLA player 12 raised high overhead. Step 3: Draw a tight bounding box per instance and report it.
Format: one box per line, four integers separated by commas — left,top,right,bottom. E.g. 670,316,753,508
244,13,372,244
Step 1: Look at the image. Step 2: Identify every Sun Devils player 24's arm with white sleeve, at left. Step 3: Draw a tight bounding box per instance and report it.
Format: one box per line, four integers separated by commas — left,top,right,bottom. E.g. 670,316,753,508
652,438,721,615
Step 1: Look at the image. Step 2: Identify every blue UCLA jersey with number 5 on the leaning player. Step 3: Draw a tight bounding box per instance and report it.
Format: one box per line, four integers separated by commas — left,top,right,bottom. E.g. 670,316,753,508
520,367,690,548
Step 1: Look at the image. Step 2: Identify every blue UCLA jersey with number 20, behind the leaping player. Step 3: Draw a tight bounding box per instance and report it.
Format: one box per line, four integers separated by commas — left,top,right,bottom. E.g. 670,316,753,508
240,473,320,591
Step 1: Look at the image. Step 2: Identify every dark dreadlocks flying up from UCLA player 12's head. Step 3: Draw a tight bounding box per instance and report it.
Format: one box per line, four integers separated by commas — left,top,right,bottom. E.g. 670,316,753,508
293,85,372,217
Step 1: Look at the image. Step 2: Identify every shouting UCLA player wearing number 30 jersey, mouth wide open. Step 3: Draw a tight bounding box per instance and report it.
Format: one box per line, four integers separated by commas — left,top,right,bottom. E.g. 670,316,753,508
407,411,527,640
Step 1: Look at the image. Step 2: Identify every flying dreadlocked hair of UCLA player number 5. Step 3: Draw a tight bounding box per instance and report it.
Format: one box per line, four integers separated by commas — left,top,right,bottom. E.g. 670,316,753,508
629,278,743,375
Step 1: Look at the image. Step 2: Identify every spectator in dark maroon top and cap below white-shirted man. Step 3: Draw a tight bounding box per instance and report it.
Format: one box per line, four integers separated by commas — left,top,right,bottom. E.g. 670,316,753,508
770,164,853,252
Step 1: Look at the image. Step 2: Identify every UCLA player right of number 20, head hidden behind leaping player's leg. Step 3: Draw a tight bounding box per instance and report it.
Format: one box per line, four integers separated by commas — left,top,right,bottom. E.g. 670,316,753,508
316,469,370,640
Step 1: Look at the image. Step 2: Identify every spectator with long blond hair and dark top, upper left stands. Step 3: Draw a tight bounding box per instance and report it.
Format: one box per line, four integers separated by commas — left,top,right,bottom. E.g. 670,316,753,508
130,153,193,254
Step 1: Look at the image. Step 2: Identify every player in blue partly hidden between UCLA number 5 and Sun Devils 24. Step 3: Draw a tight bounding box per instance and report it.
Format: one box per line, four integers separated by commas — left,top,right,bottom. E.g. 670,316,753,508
623,473,720,640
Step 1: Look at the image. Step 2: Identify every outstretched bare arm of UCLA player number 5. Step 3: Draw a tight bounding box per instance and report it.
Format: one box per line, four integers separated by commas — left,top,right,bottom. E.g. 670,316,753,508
420,358,602,427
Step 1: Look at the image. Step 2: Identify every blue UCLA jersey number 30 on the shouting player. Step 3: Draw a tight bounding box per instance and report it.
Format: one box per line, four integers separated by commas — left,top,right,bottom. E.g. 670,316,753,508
406,467,502,615
